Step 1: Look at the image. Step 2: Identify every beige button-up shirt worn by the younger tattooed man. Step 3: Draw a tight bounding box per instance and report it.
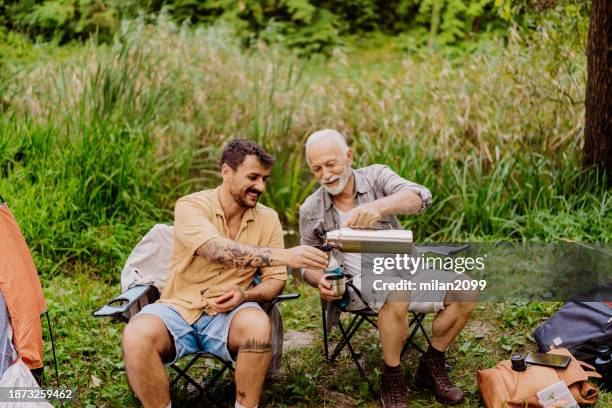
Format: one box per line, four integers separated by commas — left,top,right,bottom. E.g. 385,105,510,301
159,187,287,324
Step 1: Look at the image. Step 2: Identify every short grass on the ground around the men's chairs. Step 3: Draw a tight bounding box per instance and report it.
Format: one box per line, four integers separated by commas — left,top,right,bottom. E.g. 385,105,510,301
40,276,612,408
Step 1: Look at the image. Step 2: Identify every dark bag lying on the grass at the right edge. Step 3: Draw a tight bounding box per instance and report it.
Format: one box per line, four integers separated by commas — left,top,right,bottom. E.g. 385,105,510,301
533,283,612,361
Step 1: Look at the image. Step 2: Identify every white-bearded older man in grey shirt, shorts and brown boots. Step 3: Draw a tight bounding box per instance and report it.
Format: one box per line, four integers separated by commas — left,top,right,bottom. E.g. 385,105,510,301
300,129,475,408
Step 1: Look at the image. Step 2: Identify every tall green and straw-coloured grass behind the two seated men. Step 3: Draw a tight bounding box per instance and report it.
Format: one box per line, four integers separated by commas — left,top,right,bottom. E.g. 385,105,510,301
0,15,612,276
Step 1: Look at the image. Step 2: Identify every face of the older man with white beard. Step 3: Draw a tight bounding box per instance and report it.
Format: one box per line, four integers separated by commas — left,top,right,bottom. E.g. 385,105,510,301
308,138,353,195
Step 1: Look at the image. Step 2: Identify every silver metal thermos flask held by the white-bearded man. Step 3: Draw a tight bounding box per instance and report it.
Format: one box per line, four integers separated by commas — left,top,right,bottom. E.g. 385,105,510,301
326,228,412,254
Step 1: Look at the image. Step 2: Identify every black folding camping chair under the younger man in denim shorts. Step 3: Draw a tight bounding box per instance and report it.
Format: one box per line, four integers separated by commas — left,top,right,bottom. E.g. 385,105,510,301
93,284,300,405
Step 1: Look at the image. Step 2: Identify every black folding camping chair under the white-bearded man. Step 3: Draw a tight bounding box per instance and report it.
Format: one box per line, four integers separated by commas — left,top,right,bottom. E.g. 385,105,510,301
321,244,469,378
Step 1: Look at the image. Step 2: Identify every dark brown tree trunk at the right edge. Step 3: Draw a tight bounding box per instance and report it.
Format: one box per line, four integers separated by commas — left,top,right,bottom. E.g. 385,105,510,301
583,0,612,184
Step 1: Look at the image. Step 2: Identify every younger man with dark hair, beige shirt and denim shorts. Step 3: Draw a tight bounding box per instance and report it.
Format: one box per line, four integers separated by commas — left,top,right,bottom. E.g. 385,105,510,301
123,140,327,408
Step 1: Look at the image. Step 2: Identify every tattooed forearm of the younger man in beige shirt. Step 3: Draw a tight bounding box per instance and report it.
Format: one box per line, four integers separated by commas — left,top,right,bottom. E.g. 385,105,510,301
204,240,272,268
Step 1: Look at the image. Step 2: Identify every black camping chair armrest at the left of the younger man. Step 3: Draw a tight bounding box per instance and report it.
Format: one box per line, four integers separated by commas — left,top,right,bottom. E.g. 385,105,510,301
92,285,159,322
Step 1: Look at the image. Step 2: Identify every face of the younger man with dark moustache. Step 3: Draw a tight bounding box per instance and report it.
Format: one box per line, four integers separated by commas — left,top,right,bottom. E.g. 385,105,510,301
222,155,270,208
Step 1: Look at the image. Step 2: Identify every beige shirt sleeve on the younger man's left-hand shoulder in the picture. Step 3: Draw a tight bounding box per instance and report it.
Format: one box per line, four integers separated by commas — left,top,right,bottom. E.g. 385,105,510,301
174,198,221,254
